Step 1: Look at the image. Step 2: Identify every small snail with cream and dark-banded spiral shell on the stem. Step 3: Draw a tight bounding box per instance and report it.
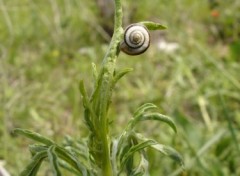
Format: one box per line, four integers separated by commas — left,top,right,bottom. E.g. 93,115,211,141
120,23,150,55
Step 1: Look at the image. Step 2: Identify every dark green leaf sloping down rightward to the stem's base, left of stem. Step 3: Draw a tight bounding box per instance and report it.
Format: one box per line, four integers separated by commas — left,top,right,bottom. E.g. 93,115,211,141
55,146,87,176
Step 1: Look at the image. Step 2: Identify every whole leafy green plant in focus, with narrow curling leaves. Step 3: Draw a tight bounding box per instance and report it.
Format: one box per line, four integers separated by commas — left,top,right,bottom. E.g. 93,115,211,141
14,0,183,176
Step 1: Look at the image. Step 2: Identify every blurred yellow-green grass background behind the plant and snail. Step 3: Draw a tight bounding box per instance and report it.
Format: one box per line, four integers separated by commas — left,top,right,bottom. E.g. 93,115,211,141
0,0,240,176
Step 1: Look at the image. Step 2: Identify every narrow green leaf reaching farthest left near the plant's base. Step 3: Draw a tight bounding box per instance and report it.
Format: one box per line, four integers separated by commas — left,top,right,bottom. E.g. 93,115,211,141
13,128,54,146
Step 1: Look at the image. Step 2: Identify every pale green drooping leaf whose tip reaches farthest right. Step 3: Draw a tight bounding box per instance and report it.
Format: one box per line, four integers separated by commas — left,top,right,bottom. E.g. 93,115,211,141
136,133,183,165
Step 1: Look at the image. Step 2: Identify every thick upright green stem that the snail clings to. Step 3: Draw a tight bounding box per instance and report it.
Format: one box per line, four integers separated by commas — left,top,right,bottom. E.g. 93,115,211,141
91,0,123,176
